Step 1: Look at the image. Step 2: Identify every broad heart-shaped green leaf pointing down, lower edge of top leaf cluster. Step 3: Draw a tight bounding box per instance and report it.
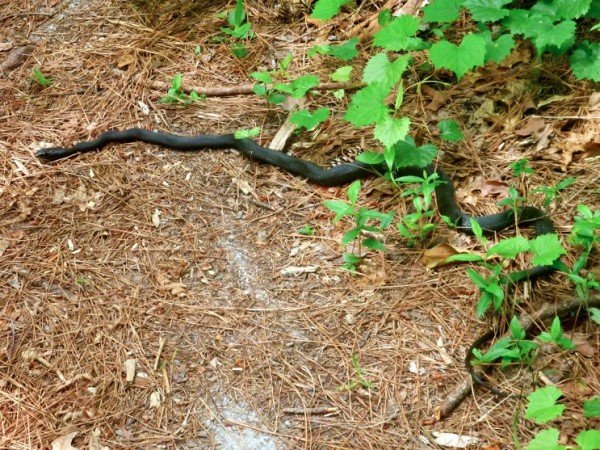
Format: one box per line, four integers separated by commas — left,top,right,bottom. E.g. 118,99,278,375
429,34,486,80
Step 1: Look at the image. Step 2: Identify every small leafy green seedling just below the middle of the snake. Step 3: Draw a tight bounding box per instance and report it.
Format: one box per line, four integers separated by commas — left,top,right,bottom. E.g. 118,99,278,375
323,180,394,271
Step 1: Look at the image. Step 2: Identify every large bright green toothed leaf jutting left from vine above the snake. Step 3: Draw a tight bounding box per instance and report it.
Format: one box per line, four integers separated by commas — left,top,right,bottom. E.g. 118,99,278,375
344,83,389,127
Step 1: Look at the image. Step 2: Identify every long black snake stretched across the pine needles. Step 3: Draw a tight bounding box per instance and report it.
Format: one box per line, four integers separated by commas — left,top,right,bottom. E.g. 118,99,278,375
36,128,554,283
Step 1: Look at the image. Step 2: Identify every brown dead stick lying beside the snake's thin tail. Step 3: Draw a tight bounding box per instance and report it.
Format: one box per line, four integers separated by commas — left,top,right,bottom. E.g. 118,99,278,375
434,295,600,421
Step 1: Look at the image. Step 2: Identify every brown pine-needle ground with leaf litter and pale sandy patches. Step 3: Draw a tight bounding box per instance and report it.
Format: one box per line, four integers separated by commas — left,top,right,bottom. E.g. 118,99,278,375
0,0,600,450
